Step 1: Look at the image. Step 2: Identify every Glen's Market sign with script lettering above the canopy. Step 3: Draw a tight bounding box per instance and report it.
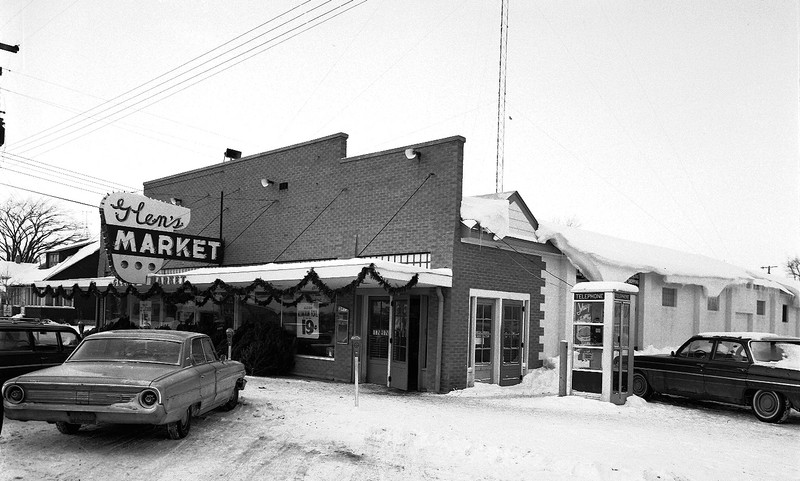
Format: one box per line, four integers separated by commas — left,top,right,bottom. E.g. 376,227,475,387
100,192,223,284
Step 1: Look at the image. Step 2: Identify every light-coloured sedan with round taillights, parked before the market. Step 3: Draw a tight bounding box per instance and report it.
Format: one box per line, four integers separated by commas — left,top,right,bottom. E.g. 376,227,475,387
2,329,246,439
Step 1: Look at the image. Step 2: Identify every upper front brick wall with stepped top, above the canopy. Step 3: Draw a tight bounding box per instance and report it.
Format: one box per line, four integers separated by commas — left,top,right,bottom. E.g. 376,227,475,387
144,134,464,267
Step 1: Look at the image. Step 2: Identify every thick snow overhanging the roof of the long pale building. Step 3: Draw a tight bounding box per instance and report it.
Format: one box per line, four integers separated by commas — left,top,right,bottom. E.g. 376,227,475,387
536,221,800,305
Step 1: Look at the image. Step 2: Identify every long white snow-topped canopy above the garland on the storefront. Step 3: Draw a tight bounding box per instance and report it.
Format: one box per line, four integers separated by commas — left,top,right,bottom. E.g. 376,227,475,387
149,258,453,289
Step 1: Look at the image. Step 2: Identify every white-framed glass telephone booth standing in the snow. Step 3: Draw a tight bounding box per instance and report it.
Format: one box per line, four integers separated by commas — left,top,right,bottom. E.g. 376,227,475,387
567,282,639,404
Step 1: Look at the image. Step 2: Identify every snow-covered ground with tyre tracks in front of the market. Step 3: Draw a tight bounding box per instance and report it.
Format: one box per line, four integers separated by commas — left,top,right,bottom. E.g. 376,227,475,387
0,368,800,481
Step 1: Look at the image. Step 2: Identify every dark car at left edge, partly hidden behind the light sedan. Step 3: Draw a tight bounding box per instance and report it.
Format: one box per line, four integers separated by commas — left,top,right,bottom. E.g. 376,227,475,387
0,318,81,430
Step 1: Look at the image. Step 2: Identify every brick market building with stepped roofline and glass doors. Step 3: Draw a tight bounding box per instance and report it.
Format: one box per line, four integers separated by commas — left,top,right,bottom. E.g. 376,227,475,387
125,134,555,392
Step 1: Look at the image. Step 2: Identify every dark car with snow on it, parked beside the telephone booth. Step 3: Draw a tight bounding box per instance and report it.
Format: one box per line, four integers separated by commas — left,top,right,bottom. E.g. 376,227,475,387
632,332,800,423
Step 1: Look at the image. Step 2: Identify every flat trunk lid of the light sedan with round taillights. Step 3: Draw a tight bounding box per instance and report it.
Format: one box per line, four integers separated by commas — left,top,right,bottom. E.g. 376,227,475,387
13,362,181,385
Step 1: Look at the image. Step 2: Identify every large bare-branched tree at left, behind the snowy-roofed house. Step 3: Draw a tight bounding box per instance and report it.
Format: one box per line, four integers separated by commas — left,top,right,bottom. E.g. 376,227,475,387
0,198,83,262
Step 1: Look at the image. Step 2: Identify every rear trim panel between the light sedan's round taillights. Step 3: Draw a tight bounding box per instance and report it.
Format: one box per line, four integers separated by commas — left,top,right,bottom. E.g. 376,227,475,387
23,386,142,406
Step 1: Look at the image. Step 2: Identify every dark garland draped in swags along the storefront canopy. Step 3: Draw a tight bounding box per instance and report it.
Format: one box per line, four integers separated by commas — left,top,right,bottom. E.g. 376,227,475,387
31,264,419,307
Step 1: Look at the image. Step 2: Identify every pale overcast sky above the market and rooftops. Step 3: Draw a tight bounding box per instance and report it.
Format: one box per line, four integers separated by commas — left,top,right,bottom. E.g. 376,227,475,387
0,0,800,273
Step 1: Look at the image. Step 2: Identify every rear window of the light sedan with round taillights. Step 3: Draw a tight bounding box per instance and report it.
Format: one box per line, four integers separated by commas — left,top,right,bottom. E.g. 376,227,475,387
69,337,181,364
